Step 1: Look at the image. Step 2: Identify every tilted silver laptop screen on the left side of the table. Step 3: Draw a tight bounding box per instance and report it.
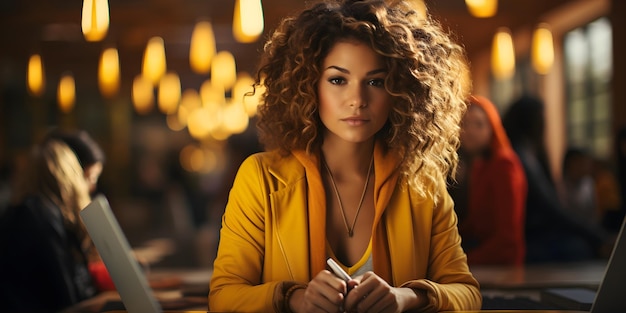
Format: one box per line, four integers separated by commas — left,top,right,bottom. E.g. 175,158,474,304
80,195,163,313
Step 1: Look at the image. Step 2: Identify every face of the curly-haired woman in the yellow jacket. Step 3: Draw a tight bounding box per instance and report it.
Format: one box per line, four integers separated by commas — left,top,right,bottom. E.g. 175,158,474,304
318,41,391,143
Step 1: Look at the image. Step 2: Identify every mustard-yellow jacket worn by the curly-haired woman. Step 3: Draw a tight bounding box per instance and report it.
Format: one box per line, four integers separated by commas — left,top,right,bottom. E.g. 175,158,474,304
209,145,481,312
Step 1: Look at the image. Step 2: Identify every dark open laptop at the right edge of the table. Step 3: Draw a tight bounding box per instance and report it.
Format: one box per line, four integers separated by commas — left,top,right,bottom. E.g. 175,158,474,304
541,219,626,313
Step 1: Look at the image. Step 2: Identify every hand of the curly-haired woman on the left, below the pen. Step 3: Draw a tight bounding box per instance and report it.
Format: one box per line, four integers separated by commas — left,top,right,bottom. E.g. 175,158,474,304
289,270,347,312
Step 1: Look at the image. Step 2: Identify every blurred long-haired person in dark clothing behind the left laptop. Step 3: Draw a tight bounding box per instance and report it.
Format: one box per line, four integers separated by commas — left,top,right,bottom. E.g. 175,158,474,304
0,130,113,312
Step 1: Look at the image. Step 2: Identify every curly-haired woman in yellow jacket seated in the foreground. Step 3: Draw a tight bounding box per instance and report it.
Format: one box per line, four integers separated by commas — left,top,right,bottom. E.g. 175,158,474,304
209,0,481,312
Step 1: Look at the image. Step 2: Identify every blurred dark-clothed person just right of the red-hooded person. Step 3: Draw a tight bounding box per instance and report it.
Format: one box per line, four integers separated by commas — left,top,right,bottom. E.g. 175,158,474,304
503,95,609,263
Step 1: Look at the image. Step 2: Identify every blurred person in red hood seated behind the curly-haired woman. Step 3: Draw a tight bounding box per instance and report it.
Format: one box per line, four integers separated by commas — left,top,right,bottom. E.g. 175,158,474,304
451,96,527,265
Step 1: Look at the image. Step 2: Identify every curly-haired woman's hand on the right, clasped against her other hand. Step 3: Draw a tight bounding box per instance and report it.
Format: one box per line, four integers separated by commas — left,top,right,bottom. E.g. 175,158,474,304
345,272,424,313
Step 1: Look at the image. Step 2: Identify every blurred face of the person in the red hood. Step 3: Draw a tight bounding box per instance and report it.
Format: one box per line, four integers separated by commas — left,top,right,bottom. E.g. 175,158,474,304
461,105,493,154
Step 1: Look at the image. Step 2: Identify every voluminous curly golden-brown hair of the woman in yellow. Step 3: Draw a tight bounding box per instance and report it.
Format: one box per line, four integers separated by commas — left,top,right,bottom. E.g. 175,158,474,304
256,0,469,195
